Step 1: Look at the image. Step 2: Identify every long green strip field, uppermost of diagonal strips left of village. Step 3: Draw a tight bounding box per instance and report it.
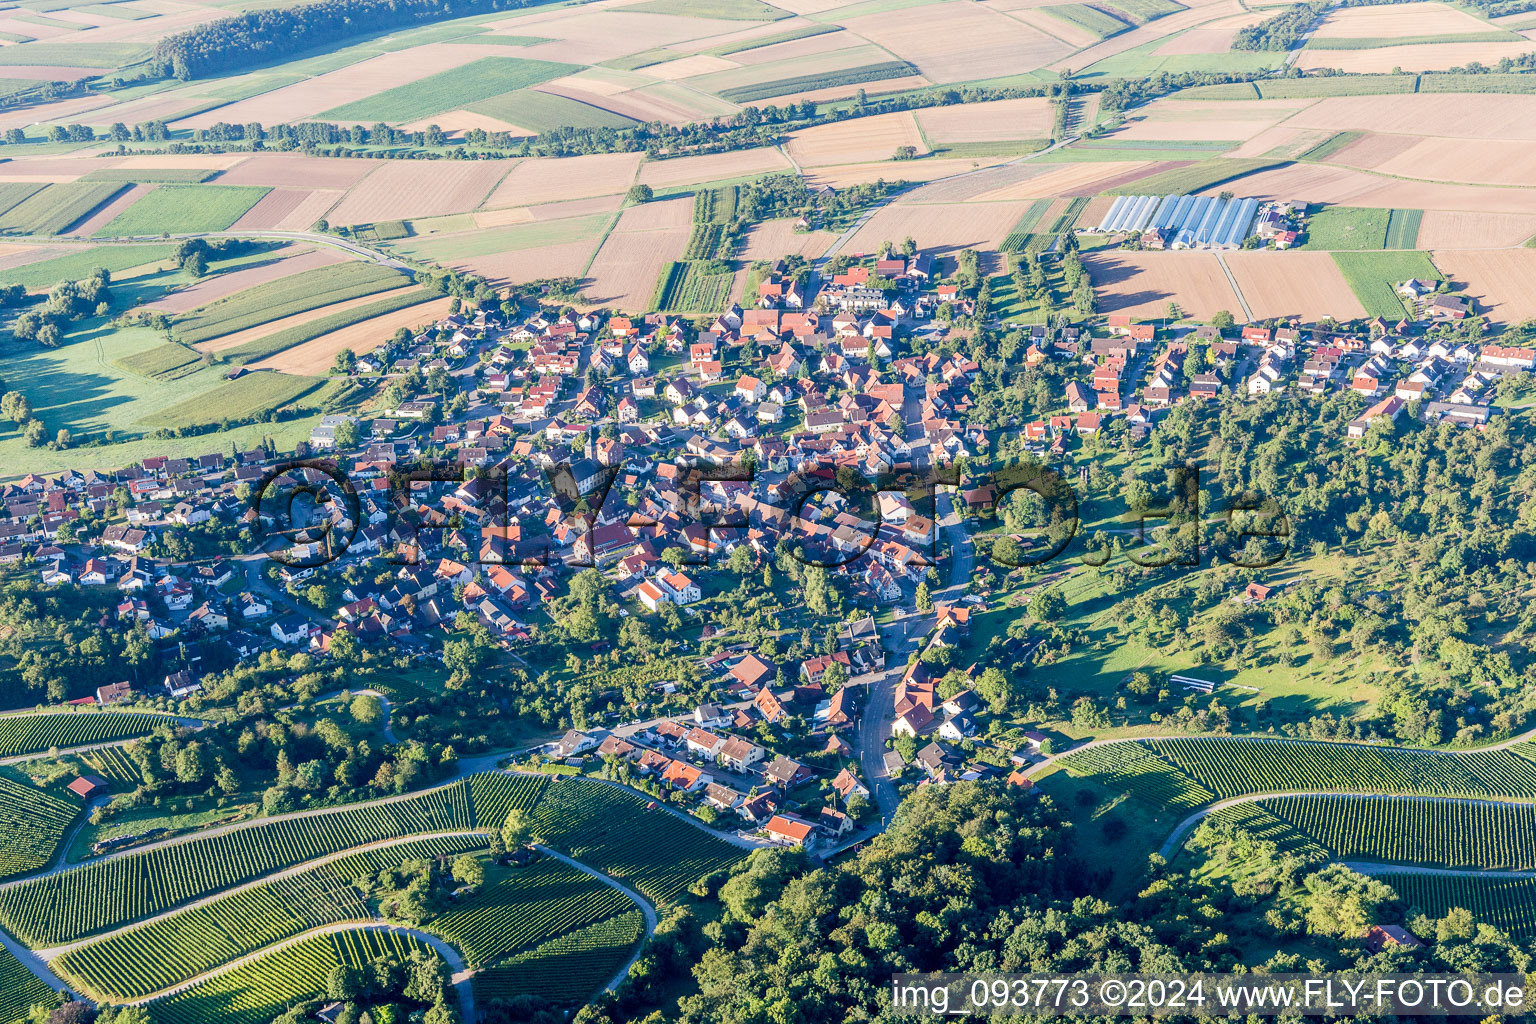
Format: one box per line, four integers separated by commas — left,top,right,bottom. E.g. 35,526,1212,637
172,263,409,345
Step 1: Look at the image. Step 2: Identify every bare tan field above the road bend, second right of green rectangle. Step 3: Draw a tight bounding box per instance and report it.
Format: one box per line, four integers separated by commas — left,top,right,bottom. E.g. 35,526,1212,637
327,160,516,224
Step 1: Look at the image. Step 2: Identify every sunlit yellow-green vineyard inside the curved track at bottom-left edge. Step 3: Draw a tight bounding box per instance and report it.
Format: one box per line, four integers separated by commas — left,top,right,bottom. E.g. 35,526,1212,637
154,929,432,1024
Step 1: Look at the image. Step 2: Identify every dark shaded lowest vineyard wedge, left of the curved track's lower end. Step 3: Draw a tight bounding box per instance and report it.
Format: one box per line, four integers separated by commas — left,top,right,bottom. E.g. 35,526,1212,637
475,910,644,1004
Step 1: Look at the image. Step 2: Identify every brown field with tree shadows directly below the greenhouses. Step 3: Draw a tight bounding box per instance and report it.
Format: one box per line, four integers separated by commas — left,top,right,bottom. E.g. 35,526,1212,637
1083,252,1243,319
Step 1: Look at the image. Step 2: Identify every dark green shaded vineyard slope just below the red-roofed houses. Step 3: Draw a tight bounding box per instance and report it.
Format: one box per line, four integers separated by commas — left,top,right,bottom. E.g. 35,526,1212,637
531,778,742,903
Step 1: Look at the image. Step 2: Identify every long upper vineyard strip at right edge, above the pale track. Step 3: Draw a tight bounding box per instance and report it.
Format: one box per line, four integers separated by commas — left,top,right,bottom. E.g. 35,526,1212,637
1141,737,1536,800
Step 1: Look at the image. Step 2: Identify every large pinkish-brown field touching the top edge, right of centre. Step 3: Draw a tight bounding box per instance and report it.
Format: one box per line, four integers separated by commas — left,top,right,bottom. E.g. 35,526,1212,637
837,2,1081,83
